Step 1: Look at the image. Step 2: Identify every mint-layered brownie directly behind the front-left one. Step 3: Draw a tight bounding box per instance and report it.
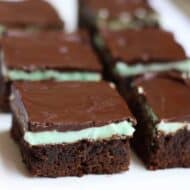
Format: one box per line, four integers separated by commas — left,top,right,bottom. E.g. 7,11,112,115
1,31,102,81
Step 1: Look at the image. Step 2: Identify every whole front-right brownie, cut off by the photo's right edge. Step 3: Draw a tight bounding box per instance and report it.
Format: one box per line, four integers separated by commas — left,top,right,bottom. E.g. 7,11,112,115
124,75,190,170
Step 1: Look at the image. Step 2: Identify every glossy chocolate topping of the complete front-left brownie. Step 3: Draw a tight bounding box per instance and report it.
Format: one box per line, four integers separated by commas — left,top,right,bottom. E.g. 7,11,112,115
12,82,134,131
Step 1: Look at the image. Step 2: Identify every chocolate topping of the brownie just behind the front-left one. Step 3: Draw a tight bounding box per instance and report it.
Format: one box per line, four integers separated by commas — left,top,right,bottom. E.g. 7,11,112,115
2,31,102,72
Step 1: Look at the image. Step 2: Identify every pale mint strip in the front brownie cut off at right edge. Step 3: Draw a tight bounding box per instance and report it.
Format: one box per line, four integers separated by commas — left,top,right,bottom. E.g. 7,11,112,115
156,122,190,135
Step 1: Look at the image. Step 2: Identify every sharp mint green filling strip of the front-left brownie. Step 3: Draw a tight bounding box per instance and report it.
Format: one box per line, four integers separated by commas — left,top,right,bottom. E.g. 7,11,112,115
24,121,134,146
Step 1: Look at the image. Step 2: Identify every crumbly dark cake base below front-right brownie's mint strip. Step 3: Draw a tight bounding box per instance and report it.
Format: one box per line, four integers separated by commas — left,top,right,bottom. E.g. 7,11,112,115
132,126,190,170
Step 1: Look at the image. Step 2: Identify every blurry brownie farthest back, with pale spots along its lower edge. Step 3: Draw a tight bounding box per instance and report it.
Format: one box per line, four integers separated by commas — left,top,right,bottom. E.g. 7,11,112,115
80,0,158,30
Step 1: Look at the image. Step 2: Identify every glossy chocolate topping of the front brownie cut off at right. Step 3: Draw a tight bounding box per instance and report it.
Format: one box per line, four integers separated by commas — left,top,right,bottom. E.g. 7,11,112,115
136,76,190,122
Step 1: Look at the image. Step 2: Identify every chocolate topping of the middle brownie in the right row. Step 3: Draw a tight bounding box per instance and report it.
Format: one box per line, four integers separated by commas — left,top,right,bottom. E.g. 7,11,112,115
102,29,186,64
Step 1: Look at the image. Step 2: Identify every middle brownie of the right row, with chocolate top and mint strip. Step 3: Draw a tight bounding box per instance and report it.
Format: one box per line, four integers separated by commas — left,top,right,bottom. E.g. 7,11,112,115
95,28,190,78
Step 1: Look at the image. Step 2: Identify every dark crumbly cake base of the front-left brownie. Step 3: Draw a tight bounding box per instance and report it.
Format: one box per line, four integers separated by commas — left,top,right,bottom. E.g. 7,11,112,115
11,113,130,177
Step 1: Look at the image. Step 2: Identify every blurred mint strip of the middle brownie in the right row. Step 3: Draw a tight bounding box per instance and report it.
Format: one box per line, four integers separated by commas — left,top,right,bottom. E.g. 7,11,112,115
114,59,190,77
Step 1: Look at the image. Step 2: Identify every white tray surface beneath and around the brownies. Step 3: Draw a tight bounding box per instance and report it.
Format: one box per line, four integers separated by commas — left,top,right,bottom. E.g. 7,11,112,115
0,0,190,190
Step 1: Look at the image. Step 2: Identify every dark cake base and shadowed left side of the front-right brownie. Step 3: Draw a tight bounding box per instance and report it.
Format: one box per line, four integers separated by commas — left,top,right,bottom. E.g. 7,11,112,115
120,86,190,170
